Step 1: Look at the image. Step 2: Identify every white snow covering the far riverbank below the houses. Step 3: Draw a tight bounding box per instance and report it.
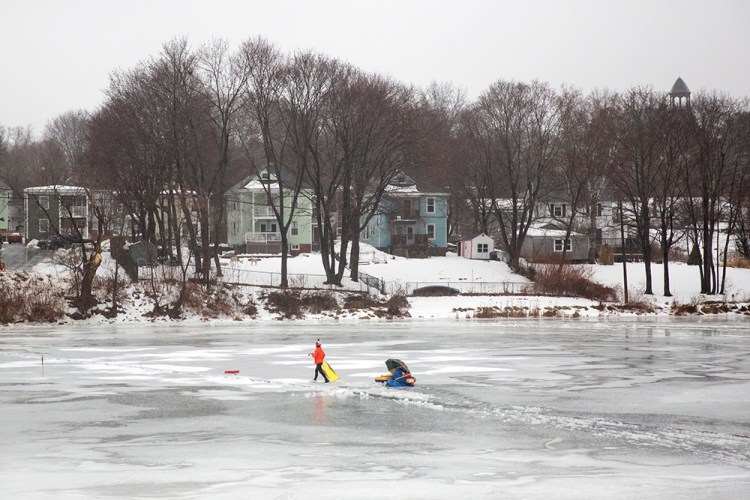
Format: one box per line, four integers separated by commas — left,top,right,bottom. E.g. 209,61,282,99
5,248,750,323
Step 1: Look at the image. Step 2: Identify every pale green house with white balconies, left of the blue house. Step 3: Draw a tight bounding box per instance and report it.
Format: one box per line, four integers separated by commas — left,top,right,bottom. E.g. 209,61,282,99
225,170,313,255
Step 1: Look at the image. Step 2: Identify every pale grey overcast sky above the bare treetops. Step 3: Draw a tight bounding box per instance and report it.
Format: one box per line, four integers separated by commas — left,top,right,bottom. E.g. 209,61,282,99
0,0,750,134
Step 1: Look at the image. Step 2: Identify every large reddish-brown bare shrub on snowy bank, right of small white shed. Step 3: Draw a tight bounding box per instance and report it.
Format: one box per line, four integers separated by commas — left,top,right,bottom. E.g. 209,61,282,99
534,264,617,302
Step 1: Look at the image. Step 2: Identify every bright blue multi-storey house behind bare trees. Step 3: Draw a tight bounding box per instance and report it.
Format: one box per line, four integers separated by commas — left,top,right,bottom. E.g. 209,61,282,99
360,174,448,257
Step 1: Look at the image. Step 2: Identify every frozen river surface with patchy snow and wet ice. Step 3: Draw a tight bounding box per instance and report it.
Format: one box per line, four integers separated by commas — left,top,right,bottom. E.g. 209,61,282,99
0,320,750,500
